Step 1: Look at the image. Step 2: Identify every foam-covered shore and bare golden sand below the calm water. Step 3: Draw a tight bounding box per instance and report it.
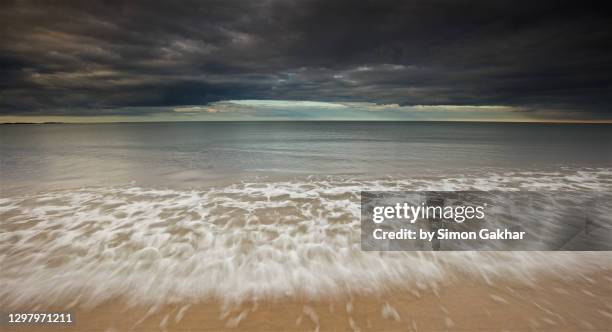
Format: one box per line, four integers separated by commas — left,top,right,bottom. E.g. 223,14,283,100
0,169,612,332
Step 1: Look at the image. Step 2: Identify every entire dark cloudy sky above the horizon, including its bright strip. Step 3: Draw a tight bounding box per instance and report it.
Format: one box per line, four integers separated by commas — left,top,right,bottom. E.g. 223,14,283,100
0,0,612,122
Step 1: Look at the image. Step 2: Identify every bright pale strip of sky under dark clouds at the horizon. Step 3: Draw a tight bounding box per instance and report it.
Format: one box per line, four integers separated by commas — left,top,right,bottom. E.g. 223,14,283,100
0,99,603,123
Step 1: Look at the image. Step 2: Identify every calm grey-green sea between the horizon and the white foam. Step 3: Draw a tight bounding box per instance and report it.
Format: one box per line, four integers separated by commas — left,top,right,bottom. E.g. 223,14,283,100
0,122,612,192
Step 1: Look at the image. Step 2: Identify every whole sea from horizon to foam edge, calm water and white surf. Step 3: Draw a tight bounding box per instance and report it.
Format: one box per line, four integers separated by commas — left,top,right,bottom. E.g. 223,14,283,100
0,122,612,308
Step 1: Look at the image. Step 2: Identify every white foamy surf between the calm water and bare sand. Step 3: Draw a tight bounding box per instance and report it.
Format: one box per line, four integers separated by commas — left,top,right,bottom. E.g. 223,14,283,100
0,169,612,308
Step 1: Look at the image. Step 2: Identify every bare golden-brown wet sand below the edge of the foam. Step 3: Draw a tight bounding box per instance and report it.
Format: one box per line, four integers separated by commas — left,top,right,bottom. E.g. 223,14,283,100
2,266,612,331
